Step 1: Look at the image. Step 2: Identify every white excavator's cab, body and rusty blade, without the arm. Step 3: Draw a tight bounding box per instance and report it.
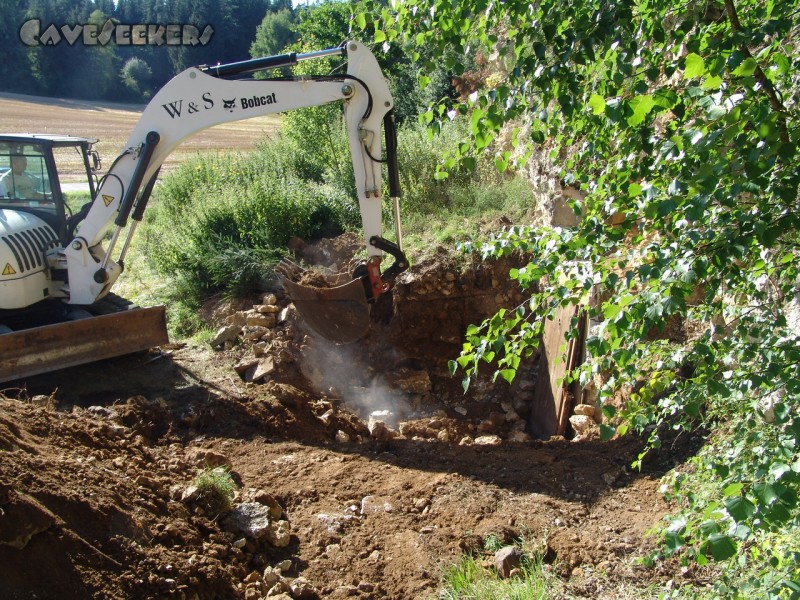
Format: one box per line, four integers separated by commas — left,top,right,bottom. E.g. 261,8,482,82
0,133,168,381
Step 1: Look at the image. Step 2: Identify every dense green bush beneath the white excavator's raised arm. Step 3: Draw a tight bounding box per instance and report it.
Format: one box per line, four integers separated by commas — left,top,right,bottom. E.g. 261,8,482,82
143,140,359,304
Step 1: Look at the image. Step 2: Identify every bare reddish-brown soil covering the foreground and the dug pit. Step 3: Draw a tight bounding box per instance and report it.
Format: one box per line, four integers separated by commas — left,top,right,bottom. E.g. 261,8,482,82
0,240,698,600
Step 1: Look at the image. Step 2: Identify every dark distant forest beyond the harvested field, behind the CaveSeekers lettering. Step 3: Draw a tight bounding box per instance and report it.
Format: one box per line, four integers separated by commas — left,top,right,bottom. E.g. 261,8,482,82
0,0,306,102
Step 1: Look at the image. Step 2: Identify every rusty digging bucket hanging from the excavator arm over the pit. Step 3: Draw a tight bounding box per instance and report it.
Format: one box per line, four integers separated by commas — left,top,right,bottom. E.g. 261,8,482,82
275,259,370,344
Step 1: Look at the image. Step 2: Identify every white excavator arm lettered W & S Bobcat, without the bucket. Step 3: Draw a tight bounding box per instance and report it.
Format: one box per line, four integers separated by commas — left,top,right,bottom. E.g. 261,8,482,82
59,42,395,304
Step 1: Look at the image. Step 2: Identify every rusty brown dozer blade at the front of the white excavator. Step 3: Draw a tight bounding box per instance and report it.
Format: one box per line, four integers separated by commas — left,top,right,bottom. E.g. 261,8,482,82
0,306,169,382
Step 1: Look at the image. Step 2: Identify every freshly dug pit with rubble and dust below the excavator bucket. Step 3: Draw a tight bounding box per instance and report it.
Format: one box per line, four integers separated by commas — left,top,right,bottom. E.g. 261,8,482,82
210,236,538,443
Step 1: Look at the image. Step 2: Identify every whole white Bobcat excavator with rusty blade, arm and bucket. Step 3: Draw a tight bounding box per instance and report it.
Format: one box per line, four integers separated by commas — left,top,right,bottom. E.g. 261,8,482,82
0,41,408,381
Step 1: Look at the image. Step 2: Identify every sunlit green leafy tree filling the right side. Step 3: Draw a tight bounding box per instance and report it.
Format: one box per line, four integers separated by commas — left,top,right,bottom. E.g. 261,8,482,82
364,0,800,596
